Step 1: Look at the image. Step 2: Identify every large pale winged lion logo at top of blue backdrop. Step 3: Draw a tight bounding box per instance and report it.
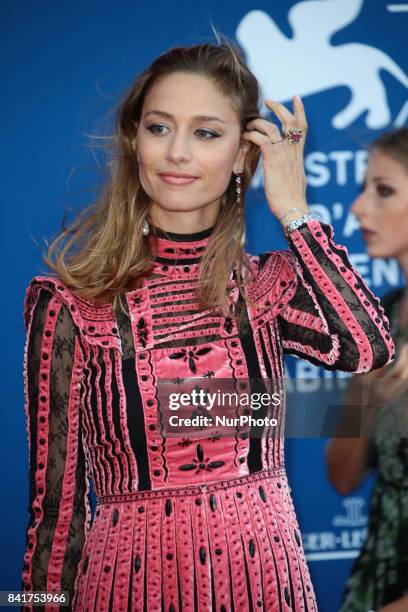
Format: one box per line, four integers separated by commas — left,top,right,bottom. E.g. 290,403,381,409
236,0,408,130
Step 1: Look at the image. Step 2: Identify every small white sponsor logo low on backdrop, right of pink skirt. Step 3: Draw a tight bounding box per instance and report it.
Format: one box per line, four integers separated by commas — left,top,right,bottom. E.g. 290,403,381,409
302,497,368,561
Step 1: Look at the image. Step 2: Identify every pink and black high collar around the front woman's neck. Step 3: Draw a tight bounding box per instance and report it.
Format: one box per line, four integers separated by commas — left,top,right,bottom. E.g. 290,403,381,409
149,227,214,265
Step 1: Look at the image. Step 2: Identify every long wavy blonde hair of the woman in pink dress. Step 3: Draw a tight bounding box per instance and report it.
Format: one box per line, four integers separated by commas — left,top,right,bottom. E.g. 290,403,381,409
43,42,259,310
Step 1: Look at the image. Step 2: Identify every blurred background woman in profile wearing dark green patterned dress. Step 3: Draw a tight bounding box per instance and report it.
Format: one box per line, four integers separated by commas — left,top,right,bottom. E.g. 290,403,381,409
327,128,408,612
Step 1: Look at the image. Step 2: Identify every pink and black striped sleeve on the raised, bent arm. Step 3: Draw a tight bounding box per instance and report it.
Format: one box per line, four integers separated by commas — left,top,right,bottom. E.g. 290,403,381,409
280,221,394,372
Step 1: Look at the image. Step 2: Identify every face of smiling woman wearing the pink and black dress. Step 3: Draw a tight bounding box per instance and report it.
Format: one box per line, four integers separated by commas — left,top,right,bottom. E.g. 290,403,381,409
136,72,244,231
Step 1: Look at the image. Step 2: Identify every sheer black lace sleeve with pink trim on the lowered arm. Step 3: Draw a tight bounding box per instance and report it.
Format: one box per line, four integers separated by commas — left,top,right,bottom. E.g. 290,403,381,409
23,288,90,610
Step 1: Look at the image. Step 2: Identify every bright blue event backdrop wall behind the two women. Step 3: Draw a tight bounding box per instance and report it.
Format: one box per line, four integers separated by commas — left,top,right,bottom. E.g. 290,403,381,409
0,0,408,612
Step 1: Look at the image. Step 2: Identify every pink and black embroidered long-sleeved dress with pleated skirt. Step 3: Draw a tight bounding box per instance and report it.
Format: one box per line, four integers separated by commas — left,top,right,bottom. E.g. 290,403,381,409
23,220,393,612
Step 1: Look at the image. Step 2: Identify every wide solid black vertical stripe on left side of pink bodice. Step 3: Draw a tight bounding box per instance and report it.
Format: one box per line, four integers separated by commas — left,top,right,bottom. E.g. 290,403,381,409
119,357,152,491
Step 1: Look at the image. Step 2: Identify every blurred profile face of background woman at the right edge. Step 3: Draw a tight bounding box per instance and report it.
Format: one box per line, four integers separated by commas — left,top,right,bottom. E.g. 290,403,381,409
351,149,408,259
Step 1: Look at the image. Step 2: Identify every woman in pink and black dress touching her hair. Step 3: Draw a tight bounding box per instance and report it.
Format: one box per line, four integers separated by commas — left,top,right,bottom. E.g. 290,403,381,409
23,44,393,612
